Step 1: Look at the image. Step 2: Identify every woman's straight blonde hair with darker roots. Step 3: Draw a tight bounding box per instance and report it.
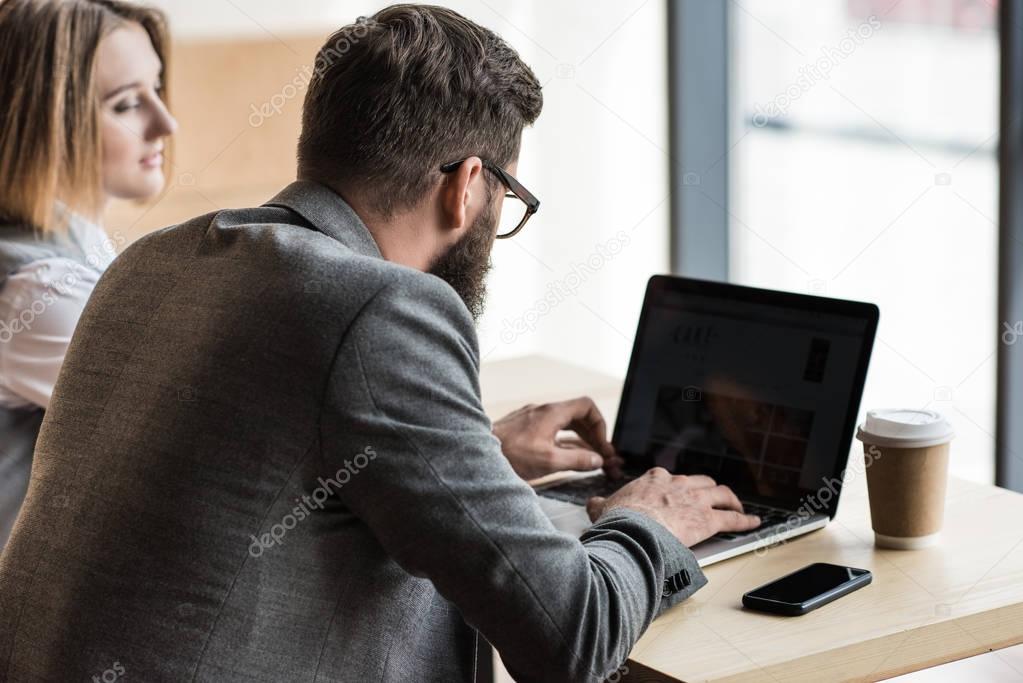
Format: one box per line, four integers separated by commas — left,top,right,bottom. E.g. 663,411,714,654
0,0,168,232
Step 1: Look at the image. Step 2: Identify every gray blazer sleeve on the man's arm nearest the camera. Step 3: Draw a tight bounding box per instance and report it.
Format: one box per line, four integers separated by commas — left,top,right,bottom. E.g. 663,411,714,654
321,273,706,681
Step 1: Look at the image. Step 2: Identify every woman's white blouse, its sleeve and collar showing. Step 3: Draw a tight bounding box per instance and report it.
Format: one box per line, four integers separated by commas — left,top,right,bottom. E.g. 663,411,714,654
0,216,117,408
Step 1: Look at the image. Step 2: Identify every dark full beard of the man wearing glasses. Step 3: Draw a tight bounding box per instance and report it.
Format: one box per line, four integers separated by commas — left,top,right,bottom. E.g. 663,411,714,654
430,201,497,321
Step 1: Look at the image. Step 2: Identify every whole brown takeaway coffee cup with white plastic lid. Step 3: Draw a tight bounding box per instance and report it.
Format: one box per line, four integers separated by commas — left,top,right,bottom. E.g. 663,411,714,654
856,408,954,550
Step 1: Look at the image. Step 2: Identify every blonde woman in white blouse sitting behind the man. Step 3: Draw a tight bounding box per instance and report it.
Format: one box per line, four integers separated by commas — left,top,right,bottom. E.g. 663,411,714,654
0,0,177,549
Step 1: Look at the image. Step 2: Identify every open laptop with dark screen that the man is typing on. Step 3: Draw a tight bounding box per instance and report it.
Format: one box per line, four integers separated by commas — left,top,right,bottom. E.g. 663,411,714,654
537,275,879,566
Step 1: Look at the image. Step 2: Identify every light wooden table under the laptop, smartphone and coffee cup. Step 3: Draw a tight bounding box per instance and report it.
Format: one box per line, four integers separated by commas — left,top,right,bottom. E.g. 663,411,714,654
481,356,1023,682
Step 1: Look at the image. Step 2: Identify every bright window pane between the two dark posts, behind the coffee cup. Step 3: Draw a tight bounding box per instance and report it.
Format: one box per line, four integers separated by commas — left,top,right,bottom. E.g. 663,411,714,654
729,0,998,483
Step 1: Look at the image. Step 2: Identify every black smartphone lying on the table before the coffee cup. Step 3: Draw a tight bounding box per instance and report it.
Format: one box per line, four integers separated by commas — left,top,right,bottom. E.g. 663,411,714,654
743,562,873,617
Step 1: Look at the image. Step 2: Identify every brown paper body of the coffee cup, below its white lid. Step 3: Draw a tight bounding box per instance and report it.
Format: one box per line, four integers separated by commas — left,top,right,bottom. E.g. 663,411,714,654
862,437,949,550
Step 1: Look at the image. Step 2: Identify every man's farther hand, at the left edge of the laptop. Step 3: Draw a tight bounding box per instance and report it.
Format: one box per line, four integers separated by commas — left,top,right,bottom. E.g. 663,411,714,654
493,398,622,481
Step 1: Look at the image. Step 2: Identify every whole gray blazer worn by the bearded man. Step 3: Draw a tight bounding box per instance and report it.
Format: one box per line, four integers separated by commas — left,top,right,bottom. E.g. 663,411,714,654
0,182,706,683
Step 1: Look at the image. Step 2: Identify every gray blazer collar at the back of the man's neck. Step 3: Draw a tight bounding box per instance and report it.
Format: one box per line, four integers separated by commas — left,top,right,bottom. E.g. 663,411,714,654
263,180,384,259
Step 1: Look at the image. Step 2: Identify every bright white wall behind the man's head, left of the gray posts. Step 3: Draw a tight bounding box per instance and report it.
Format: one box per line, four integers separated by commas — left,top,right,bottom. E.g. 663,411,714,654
149,0,669,374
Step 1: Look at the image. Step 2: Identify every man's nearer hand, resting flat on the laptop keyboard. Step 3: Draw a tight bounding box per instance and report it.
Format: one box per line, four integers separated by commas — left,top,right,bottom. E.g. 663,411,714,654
586,467,760,547
